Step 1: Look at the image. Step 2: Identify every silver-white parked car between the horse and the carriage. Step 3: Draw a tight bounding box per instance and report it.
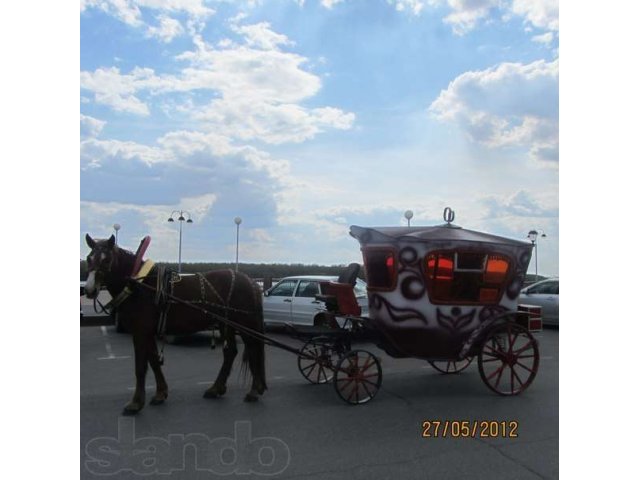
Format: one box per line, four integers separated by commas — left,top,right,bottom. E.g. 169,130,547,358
263,275,369,325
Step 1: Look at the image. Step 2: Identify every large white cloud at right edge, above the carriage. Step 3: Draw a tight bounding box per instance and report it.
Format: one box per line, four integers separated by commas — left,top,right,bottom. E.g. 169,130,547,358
429,60,559,161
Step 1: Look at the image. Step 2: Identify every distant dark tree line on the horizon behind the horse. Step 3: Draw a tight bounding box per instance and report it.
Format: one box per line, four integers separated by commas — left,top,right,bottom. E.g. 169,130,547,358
80,260,364,280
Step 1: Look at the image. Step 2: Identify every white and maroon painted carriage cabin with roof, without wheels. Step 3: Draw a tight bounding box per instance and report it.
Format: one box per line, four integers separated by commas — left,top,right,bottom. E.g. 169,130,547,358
350,223,532,360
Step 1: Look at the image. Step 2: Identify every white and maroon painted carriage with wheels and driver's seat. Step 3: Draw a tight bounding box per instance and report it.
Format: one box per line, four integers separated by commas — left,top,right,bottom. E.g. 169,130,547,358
296,209,542,404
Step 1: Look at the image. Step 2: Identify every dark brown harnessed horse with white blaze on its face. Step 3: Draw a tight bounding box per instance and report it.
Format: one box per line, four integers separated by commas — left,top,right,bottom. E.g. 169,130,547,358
85,234,267,415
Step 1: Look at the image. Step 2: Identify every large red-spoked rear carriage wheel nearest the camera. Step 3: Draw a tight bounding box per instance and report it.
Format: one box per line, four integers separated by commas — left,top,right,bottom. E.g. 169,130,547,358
478,322,540,395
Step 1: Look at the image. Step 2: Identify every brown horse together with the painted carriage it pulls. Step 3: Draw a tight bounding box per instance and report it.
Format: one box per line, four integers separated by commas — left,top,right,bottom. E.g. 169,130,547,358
87,208,542,414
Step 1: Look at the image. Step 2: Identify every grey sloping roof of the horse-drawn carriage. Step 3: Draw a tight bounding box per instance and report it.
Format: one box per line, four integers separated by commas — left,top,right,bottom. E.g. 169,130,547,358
349,223,531,247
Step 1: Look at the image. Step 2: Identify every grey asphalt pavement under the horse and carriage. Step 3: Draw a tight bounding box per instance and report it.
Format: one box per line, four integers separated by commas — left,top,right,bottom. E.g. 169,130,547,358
80,326,559,480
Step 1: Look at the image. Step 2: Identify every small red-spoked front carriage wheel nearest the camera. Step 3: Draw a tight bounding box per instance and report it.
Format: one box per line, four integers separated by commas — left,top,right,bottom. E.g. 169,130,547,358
333,350,382,405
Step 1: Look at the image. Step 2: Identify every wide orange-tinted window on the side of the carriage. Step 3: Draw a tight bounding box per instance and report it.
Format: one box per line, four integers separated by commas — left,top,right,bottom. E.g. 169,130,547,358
425,251,509,304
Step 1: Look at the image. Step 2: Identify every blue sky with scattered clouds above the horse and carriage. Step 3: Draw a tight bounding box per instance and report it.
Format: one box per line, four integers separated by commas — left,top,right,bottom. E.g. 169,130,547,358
79,0,559,275
